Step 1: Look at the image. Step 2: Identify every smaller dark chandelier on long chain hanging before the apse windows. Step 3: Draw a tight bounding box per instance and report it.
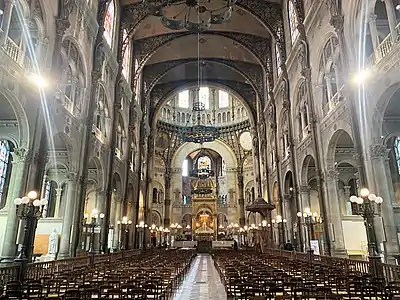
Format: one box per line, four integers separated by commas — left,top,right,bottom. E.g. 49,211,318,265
181,33,219,144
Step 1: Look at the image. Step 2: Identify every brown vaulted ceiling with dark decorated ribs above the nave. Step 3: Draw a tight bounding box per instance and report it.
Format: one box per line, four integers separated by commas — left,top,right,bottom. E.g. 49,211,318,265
121,0,290,164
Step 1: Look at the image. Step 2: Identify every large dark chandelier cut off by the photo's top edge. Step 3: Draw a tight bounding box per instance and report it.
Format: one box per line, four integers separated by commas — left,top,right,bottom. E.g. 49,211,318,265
143,0,237,32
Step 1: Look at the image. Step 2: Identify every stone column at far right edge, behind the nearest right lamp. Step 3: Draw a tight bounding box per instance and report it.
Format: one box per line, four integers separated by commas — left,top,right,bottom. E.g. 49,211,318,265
370,144,399,262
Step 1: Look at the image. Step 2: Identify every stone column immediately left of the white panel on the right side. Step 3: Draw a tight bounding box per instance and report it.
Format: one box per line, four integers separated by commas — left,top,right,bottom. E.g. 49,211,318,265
324,166,347,256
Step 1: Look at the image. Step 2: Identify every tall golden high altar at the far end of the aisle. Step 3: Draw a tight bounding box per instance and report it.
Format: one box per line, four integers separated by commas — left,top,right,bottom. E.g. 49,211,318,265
191,173,217,242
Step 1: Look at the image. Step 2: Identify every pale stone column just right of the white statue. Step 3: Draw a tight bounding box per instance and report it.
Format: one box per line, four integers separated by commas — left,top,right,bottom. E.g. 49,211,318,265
58,172,78,259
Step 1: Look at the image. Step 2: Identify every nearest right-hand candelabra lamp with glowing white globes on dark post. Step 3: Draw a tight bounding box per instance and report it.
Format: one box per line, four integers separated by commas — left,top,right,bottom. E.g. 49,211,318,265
350,188,383,277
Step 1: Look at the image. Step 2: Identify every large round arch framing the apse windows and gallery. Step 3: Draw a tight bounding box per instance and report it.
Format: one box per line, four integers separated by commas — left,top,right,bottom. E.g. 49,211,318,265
151,81,255,130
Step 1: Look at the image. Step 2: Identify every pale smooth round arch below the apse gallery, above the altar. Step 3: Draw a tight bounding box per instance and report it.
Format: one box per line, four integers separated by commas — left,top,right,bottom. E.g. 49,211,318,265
171,140,237,169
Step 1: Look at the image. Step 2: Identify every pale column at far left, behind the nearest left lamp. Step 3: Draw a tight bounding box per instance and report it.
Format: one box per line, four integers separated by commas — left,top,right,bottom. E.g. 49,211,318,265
1,148,30,262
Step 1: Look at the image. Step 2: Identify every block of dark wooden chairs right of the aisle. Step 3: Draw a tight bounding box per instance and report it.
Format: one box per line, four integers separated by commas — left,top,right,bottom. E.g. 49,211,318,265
213,251,400,300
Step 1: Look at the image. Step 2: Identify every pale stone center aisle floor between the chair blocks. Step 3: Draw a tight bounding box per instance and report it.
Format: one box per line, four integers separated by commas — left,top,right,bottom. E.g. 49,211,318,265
174,254,227,300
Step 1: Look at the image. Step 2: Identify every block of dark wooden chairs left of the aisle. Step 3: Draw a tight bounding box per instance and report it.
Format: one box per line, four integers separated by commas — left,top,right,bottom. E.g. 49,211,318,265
0,250,195,300
